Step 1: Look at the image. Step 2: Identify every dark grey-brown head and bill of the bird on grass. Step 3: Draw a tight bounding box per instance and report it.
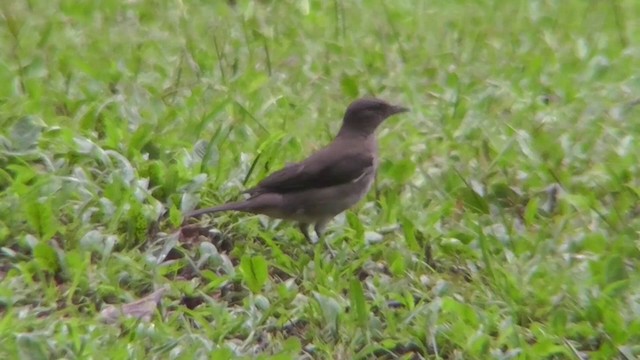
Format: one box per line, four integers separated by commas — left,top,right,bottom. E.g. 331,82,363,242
340,98,409,136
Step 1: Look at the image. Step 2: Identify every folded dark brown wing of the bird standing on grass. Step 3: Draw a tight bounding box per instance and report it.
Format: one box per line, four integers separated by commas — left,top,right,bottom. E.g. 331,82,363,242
246,149,374,195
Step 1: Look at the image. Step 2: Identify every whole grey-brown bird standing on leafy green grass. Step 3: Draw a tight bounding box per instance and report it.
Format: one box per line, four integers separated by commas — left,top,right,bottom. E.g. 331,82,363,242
186,98,409,243
